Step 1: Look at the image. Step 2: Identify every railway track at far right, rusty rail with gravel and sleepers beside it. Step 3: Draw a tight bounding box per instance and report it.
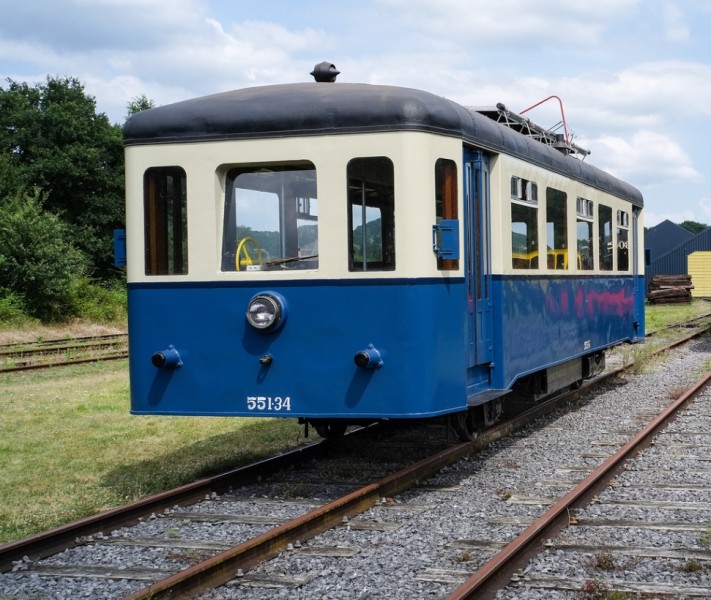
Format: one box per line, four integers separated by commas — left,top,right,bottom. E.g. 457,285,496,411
449,373,711,600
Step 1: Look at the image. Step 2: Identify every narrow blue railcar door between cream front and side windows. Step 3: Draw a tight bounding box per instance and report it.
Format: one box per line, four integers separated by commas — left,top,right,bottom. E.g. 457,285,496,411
464,149,493,370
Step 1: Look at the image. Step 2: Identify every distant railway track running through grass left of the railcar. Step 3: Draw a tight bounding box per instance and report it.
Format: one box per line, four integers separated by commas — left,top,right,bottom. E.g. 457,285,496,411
0,333,128,373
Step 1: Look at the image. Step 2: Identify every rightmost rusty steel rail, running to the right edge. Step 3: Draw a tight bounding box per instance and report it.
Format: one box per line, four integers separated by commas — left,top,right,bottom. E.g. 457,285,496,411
448,373,711,600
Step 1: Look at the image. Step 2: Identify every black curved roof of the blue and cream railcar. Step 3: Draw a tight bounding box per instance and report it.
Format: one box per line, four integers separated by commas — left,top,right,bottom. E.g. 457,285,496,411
124,83,643,207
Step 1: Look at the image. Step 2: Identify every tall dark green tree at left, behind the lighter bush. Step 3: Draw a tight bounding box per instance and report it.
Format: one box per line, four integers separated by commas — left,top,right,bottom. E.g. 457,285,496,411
0,77,124,278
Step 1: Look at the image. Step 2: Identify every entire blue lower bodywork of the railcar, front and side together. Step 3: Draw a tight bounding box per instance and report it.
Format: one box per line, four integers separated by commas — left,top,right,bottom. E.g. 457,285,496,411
129,276,644,421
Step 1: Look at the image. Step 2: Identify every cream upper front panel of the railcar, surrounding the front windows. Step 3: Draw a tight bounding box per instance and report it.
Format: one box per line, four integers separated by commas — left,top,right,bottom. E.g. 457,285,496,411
126,132,463,282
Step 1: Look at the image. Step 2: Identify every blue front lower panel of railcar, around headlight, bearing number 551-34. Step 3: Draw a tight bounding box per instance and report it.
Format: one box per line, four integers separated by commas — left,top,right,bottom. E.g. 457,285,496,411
129,279,466,420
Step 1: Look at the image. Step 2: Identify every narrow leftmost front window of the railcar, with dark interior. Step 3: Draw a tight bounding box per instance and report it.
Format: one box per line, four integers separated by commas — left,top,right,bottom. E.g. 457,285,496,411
143,167,188,275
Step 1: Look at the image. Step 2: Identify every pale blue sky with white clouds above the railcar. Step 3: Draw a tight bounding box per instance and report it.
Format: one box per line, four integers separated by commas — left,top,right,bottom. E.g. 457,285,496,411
0,0,711,226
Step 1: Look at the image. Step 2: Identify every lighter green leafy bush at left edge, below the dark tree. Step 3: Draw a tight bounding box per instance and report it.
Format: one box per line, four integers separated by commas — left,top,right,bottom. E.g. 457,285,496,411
0,190,87,321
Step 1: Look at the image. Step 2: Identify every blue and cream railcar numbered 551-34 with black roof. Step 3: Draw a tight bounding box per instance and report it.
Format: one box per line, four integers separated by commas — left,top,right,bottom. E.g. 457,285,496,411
124,65,644,436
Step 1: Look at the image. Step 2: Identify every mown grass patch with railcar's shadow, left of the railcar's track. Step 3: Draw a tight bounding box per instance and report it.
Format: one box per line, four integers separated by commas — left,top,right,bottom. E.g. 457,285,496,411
0,361,304,544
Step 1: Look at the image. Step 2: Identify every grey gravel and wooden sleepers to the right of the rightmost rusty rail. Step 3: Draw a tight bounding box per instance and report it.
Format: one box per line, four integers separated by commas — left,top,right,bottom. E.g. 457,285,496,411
498,379,711,598
